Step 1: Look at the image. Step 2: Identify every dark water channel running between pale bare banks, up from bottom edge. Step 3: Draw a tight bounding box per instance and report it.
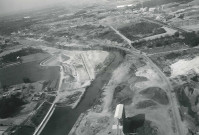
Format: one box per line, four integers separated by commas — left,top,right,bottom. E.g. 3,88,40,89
41,52,123,135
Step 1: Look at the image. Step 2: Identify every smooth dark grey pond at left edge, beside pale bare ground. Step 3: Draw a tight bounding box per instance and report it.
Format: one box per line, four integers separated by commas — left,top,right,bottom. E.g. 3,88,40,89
0,56,59,87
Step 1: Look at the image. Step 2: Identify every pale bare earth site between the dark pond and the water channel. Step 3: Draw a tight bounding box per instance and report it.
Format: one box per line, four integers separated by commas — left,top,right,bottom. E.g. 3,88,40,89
39,48,114,108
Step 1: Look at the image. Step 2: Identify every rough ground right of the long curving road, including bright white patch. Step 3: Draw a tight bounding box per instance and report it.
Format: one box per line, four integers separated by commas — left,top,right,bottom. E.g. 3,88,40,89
151,48,198,133
